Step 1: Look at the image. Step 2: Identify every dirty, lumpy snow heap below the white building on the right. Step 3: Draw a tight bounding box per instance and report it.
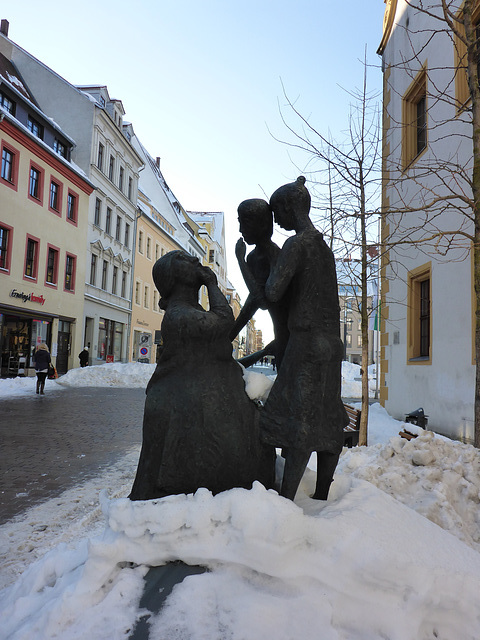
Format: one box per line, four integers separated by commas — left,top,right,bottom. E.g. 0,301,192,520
337,424,480,552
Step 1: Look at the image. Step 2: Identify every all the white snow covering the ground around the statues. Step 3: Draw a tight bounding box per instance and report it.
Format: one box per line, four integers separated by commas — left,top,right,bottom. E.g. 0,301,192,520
0,365,480,640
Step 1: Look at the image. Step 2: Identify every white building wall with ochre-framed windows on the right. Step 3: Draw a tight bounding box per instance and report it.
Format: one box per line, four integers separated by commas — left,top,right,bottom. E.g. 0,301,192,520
378,0,475,442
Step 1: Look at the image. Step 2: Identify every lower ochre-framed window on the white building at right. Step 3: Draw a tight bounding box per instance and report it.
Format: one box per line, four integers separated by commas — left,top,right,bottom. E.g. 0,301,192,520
407,263,432,364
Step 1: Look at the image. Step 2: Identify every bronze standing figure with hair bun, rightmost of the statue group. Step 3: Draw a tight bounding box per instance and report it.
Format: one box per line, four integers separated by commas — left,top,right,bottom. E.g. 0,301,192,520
260,176,348,500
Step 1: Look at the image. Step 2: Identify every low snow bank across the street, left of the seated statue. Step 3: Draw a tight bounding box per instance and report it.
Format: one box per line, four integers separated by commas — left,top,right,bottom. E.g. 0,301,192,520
57,362,156,388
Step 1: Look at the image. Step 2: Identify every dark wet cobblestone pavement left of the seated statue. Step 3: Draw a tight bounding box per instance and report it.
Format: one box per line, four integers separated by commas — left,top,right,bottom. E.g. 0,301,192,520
0,380,145,524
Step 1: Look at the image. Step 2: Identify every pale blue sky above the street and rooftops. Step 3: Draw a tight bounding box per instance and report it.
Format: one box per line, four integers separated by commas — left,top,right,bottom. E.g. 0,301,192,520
0,0,385,340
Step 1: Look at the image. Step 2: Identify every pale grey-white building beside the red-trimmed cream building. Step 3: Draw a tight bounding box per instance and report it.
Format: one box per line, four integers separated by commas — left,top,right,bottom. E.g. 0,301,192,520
0,28,142,364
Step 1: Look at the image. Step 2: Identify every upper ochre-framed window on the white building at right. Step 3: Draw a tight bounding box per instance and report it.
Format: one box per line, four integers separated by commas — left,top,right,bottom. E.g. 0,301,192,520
402,69,427,168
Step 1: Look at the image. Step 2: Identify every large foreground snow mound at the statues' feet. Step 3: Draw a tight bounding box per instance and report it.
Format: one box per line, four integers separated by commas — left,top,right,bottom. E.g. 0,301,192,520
0,480,480,640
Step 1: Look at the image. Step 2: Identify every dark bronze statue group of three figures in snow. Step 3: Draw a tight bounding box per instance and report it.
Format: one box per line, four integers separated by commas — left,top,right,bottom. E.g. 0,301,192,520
130,176,348,500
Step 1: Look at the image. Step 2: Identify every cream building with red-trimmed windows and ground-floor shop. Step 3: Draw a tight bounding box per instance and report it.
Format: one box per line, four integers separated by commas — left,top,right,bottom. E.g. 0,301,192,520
0,54,93,377
